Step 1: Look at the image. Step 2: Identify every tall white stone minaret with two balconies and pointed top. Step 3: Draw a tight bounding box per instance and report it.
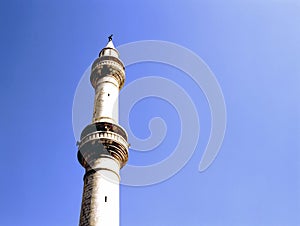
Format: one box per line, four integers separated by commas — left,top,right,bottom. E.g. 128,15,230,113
77,35,128,226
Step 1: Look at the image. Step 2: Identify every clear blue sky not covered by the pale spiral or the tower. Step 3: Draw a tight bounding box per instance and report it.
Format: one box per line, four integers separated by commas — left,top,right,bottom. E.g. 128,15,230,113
0,0,300,226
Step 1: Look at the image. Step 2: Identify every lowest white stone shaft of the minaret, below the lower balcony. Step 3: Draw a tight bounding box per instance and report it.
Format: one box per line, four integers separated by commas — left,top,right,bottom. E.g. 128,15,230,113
79,158,120,226
